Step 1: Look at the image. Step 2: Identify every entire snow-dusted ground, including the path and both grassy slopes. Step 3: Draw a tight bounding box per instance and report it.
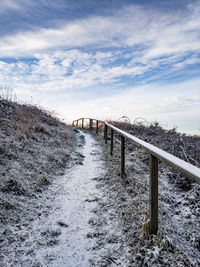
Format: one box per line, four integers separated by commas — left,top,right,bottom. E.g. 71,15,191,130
0,98,200,267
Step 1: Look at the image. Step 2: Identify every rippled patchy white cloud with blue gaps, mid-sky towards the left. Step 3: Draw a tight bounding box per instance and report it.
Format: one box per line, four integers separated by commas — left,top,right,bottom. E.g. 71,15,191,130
0,50,150,91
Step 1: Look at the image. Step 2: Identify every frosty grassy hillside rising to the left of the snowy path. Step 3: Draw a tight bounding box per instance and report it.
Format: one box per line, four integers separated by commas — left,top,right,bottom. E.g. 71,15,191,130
0,98,74,266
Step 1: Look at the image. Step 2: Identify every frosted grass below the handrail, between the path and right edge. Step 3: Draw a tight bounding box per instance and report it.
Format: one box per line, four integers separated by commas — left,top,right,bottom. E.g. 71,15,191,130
95,129,200,267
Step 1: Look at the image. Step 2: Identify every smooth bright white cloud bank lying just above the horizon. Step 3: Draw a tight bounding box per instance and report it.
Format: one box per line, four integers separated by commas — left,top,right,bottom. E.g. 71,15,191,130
53,79,200,133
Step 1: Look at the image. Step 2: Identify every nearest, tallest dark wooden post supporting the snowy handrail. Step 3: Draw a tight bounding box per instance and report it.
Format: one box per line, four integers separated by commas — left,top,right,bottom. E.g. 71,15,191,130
149,154,158,235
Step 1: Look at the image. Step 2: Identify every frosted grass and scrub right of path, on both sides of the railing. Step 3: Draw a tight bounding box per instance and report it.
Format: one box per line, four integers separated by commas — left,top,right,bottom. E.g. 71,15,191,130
102,122,200,266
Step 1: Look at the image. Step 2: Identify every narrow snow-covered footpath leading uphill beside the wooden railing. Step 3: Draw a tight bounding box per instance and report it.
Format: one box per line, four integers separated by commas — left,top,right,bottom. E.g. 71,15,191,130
23,133,103,267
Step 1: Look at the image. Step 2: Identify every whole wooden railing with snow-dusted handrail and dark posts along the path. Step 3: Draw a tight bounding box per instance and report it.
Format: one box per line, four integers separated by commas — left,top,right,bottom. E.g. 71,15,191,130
72,118,200,234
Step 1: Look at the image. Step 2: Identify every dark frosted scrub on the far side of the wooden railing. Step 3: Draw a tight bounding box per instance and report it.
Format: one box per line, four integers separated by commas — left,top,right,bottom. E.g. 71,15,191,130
111,122,200,190
